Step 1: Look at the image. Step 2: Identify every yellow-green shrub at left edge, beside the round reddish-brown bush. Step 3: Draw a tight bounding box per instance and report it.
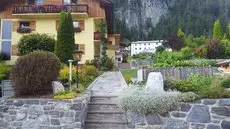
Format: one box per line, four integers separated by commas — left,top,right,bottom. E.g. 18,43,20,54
0,63,12,81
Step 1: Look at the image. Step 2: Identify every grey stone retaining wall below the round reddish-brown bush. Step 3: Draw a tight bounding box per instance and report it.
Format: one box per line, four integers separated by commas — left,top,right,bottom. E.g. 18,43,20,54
0,92,91,129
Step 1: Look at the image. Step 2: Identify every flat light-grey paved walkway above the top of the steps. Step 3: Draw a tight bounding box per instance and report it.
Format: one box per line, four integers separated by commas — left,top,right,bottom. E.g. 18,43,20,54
92,72,127,96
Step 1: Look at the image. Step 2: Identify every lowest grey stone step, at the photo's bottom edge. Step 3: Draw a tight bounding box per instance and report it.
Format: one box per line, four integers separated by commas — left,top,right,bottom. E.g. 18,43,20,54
85,120,127,129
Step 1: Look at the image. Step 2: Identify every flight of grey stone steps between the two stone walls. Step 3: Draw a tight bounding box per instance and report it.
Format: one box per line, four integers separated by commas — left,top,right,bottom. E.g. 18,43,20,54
85,96,129,129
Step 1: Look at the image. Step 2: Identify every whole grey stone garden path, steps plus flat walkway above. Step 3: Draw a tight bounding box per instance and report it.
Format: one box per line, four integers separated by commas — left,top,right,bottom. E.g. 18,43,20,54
85,72,129,129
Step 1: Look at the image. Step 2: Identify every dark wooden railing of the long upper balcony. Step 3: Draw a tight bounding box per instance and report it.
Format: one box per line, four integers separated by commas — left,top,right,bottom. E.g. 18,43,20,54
13,4,89,14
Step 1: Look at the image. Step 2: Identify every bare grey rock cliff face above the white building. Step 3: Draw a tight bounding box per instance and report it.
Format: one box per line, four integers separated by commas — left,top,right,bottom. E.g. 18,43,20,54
113,0,175,38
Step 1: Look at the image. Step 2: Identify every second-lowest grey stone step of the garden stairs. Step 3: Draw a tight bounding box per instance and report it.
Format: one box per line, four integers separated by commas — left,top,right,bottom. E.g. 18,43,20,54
87,112,127,122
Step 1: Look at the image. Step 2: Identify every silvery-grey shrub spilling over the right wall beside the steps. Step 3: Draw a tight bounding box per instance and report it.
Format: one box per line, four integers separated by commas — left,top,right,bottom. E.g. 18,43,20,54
119,87,180,115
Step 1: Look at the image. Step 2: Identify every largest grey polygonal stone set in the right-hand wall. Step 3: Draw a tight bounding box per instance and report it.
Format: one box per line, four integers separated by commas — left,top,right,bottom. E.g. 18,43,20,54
187,105,211,123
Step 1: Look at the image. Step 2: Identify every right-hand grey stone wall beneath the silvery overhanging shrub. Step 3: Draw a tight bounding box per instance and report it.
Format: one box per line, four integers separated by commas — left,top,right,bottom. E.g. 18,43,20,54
127,99,230,129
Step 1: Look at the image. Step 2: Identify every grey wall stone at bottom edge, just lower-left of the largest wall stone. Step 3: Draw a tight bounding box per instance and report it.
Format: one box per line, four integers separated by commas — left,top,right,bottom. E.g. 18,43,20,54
166,119,189,129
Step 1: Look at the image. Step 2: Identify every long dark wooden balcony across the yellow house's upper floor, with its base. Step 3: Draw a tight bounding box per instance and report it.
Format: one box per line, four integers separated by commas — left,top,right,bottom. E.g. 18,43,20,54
13,4,89,18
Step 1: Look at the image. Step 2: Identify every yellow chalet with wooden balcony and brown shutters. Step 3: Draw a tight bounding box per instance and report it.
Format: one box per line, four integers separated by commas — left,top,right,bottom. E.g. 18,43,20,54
0,0,120,64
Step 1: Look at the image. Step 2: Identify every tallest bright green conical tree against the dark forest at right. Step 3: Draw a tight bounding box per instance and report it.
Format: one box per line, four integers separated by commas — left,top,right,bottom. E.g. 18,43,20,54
213,20,223,40
